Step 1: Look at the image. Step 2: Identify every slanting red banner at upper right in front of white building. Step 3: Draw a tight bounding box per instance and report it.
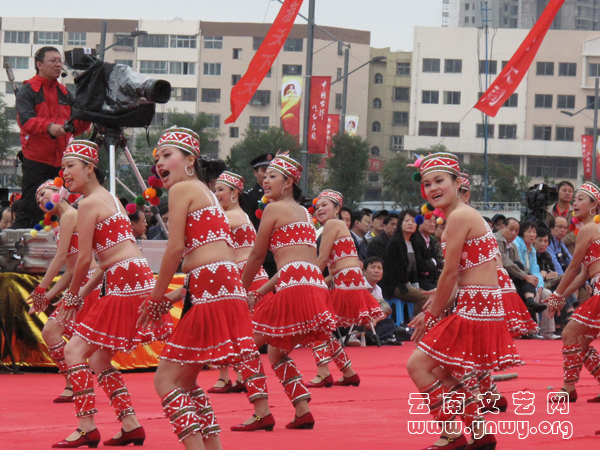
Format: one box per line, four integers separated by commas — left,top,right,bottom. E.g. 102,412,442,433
475,0,565,117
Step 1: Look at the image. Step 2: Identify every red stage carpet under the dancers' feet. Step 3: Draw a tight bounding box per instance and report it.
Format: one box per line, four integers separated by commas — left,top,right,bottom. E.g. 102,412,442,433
0,341,600,450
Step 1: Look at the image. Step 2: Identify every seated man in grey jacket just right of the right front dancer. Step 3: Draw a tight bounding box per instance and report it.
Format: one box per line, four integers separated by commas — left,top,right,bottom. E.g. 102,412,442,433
494,217,547,314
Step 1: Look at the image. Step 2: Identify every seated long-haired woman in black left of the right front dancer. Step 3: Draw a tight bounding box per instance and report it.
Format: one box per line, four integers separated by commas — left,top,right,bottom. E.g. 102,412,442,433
381,210,428,316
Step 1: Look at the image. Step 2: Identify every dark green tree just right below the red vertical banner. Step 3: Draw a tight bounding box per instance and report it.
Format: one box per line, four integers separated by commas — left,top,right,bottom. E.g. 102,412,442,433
327,134,369,208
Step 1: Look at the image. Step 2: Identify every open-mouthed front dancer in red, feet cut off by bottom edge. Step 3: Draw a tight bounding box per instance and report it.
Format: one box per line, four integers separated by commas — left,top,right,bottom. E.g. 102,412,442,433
139,127,268,450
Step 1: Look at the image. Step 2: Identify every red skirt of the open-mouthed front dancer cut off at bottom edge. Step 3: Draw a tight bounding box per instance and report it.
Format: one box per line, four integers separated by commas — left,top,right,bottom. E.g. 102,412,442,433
160,261,258,366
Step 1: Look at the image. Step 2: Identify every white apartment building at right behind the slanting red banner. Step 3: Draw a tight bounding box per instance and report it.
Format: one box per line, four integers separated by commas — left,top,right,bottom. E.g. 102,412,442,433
404,27,600,182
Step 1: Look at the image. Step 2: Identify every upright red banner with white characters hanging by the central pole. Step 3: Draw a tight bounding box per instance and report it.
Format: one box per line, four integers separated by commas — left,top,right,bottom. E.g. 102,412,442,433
308,77,331,154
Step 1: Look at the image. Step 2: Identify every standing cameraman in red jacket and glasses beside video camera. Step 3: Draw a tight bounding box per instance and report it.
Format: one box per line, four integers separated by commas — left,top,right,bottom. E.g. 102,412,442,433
12,47,90,228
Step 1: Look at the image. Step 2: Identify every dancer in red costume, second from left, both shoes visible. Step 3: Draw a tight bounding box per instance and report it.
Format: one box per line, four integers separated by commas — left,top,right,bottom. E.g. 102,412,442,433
53,141,172,448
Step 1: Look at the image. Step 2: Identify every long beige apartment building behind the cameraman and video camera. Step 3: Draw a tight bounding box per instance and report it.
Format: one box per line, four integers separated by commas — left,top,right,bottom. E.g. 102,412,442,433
0,17,371,158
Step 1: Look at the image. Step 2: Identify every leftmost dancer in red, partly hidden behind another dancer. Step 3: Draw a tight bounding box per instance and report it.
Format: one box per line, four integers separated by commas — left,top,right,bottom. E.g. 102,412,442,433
27,180,100,403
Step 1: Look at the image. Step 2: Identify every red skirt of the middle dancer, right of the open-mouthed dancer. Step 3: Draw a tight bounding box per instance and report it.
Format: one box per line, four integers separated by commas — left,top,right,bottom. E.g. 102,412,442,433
253,262,336,351
